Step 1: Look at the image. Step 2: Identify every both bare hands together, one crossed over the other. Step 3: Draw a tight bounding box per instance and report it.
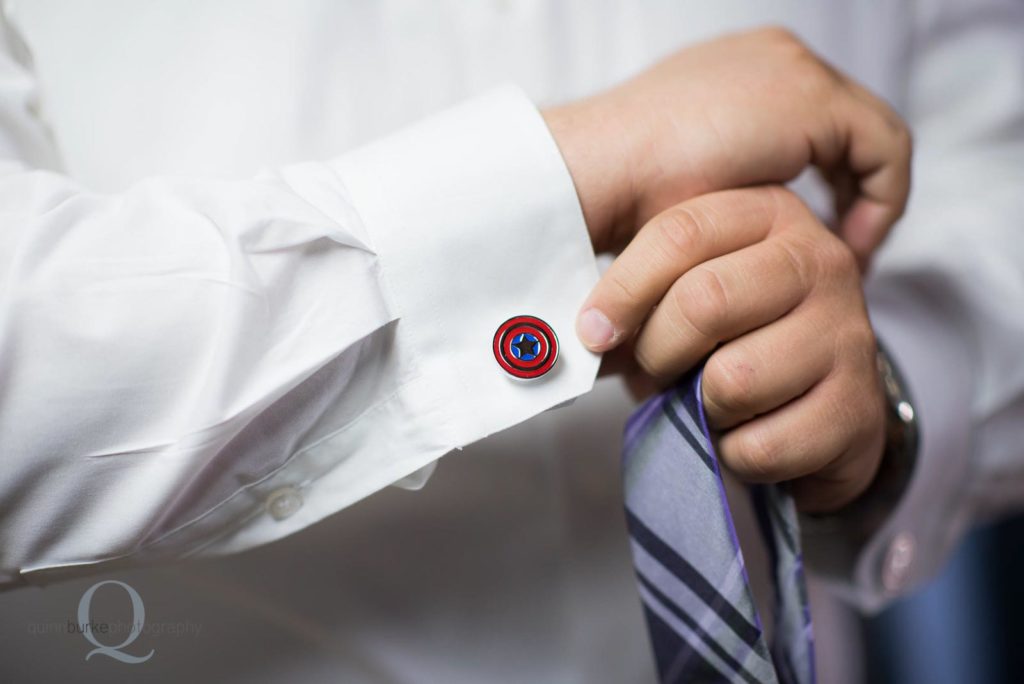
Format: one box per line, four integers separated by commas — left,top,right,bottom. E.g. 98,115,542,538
544,29,911,512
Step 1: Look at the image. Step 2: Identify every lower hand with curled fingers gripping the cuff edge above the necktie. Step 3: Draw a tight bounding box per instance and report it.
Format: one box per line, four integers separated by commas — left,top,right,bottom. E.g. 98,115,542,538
583,186,885,511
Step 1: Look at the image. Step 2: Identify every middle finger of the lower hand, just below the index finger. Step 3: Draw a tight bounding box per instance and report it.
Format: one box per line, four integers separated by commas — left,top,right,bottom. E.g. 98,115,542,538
636,238,811,383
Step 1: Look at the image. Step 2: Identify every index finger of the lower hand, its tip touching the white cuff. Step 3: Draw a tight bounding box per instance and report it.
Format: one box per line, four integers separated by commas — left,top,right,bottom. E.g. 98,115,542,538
577,188,778,351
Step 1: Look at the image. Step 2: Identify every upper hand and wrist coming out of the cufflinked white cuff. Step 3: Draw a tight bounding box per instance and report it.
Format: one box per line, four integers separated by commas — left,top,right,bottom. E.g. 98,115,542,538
545,29,910,268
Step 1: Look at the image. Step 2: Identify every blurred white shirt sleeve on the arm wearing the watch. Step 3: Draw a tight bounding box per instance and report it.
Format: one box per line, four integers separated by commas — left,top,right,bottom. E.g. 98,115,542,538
807,0,1024,609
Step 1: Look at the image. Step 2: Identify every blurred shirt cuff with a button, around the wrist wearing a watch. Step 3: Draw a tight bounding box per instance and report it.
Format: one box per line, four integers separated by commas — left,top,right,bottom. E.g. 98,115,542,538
801,277,974,612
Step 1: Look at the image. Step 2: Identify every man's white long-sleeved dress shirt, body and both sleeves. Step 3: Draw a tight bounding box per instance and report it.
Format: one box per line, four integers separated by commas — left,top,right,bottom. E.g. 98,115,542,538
0,0,1024,682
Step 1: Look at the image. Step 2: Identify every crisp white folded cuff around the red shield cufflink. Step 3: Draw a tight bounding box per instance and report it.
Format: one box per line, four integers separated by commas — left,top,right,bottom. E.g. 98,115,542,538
329,86,599,471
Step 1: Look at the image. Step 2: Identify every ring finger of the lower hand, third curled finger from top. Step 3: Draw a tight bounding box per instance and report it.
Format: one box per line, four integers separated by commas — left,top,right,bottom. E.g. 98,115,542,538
701,307,835,430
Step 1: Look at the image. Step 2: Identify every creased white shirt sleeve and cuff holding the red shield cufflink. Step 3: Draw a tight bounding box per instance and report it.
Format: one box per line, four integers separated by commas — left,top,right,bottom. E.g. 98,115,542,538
0,12,598,587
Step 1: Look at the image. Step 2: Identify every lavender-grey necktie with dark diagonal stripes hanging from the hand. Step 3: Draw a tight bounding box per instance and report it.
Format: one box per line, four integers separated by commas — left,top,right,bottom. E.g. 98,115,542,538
623,372,814,684
